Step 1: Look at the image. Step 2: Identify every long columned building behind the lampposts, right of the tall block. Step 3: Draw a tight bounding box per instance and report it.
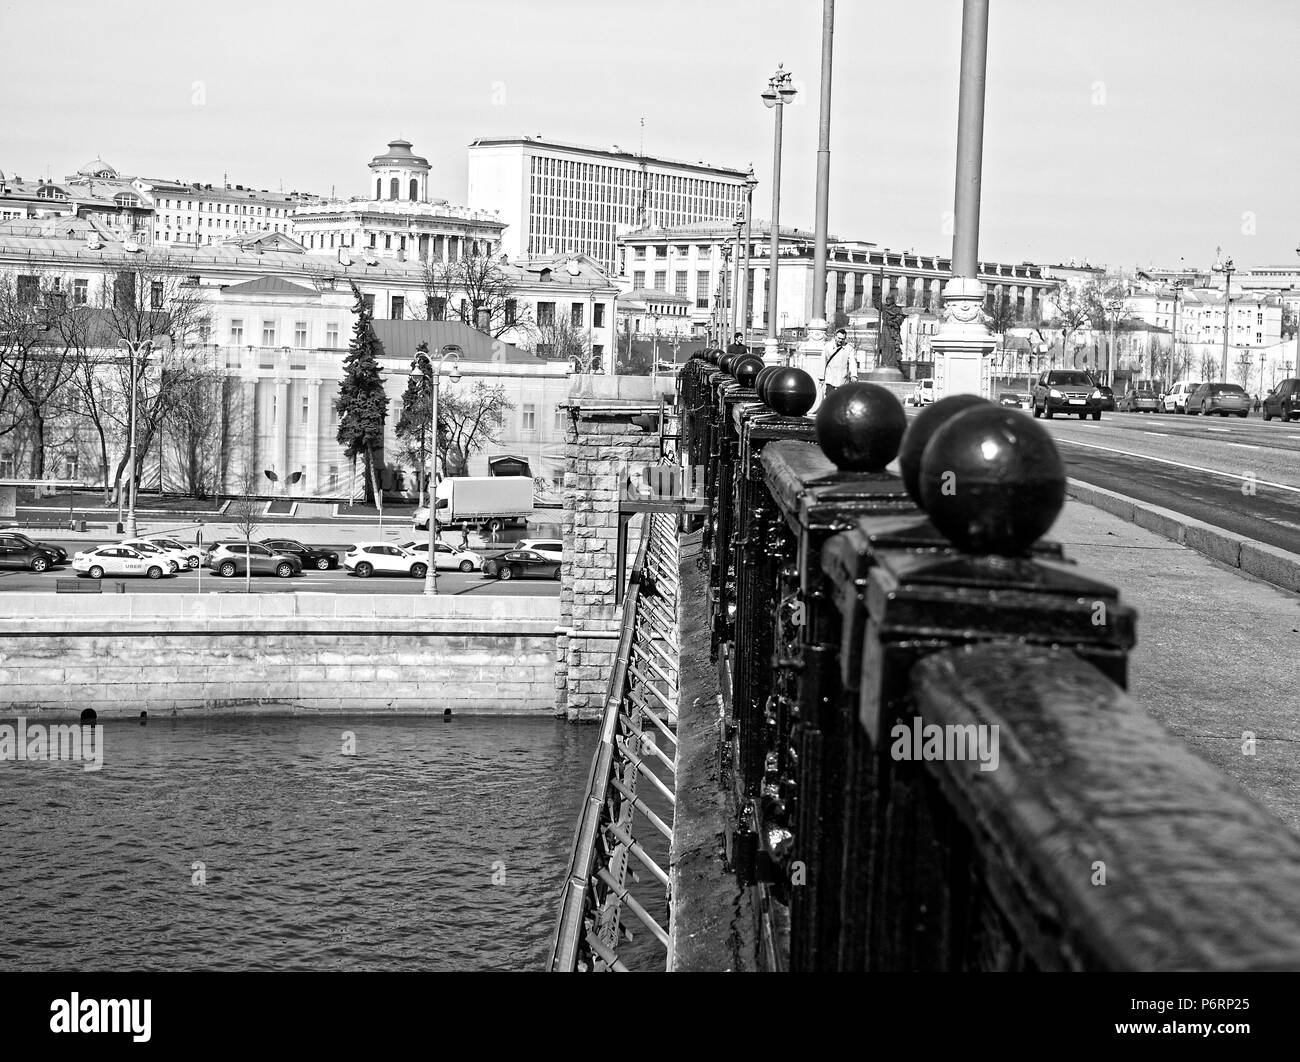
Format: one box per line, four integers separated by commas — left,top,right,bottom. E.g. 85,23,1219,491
619,220,1057,334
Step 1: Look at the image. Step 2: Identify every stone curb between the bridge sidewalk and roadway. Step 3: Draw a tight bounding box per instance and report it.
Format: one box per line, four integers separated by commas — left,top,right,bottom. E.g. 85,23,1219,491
1066,480,1300,594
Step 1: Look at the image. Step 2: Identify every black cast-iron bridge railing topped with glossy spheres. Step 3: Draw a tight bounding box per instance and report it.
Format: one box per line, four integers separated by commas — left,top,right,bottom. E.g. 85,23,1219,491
680,354,1300,970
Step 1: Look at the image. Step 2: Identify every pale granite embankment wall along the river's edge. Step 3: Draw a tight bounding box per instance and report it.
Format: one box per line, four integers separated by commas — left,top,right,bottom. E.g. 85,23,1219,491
0,593,559,716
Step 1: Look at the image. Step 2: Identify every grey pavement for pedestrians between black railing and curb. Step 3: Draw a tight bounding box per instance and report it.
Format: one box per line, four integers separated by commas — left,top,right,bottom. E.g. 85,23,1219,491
1048,499,1300,829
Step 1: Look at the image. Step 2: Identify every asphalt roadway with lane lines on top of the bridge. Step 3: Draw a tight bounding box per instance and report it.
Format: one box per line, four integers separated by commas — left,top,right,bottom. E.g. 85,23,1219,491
909,411,1300,552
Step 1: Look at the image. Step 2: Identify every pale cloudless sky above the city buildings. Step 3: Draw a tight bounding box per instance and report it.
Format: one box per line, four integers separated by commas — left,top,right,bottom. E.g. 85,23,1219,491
0,0,1300,269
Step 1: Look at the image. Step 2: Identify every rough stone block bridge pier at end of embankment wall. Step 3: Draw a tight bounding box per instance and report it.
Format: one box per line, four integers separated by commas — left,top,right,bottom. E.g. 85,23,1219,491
555,376,676,720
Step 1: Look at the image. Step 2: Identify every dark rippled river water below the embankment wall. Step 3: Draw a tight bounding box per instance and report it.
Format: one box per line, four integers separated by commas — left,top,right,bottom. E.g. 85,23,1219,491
0,716,598,970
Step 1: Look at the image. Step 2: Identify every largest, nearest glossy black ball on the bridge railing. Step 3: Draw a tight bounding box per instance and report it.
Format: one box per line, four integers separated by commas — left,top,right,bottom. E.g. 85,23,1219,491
920,403,1065,556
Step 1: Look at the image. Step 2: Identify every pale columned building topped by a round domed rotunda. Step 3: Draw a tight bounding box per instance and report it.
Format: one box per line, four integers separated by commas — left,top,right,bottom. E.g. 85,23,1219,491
291,139,506,263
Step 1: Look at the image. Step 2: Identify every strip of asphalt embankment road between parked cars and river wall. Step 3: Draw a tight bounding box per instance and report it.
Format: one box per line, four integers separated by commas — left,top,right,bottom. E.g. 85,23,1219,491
0,567,560,597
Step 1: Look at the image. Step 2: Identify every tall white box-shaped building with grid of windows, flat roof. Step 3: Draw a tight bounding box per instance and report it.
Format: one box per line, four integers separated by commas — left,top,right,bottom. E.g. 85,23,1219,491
469,136,753,270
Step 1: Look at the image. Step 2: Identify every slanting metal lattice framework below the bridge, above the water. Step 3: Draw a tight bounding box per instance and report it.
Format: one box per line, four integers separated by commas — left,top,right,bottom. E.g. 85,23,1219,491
547,513,680,972
